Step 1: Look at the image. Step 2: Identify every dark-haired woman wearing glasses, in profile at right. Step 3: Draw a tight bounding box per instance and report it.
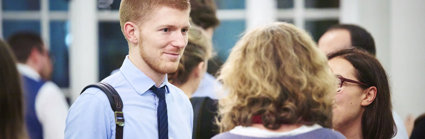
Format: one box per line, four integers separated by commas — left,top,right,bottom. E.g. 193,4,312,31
328,49,396,139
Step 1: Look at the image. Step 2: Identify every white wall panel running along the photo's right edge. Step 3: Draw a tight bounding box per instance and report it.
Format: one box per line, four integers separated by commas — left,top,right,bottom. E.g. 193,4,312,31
390,0,425,117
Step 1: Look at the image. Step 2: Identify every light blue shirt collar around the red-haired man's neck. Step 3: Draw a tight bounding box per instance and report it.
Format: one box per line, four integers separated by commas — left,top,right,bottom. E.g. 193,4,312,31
120,55,170,95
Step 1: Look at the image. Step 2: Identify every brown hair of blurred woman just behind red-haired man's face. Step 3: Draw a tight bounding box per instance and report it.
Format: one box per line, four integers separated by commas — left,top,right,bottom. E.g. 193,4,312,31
168,25,212,84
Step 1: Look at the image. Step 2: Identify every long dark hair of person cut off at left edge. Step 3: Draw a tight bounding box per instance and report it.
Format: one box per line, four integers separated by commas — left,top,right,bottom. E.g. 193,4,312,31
0,40,27,139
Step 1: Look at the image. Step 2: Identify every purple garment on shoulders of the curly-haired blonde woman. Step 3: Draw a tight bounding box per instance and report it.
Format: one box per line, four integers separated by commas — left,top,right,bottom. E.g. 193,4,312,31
212,128,345,139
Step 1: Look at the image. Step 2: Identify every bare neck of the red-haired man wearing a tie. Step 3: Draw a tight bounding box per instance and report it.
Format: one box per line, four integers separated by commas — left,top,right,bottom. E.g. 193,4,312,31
128,54,166,87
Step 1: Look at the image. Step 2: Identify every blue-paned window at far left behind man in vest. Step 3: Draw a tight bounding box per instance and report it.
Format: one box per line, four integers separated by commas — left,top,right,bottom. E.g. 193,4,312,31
0,0,69,88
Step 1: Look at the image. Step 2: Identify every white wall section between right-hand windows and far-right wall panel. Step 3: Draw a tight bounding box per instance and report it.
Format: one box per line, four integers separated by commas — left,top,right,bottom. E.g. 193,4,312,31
340,0,391,73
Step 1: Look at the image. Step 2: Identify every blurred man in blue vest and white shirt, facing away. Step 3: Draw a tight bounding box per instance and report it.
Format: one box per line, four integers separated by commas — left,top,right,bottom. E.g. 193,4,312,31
8,32,68,139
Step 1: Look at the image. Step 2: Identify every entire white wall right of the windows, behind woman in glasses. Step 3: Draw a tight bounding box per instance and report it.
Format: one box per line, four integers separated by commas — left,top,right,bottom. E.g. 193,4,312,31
341,0,425,119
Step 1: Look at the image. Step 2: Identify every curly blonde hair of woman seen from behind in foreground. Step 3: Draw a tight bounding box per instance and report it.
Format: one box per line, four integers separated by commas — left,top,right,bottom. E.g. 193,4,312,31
219,23,336,131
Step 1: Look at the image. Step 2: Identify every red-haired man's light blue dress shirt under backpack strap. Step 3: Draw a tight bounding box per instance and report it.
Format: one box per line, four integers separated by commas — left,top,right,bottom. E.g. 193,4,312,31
65,56,193,139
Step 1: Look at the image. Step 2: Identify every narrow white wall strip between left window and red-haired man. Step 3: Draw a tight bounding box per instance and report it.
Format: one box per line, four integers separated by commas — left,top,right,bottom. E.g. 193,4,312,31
69,0,98,100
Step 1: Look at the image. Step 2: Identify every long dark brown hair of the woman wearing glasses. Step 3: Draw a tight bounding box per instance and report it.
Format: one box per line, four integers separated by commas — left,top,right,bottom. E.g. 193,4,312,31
328,48,396,139
